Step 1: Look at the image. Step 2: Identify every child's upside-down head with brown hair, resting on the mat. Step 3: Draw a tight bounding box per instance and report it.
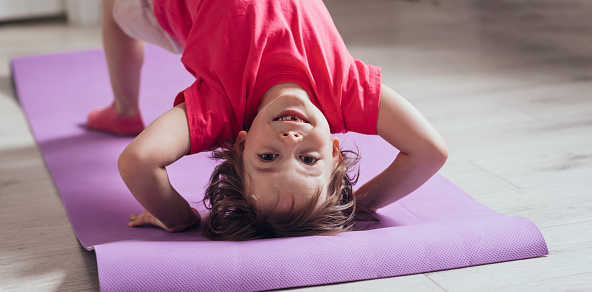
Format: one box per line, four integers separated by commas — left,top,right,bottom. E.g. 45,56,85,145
204,85,357,240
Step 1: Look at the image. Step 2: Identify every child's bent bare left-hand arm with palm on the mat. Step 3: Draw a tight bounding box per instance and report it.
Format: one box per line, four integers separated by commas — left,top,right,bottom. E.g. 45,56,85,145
118,103,200,232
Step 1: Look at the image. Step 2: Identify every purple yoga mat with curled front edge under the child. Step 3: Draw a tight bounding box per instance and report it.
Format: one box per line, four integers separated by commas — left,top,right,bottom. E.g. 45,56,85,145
12,46,548,291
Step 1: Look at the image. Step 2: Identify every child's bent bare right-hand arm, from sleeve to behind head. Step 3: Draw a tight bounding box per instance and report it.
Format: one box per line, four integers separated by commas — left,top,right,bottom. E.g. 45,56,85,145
356,85,448,210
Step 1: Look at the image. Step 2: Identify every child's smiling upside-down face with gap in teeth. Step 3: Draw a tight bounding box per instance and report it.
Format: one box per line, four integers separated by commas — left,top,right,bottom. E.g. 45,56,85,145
237,86,341,212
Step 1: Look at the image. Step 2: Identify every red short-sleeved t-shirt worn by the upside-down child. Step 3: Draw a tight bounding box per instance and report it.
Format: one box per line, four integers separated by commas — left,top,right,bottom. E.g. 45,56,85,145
154,0,380,153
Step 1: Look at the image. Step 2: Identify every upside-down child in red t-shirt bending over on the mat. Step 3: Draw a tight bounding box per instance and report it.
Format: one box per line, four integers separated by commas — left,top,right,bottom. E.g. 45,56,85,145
87,0,448,240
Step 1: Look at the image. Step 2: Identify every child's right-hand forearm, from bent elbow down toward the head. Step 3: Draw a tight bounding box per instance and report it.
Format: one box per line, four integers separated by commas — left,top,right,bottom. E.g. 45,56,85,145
355,153,446,210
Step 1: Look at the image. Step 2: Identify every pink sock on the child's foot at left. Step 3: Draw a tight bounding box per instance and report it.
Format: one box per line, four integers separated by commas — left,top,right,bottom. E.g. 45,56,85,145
86,104,144,136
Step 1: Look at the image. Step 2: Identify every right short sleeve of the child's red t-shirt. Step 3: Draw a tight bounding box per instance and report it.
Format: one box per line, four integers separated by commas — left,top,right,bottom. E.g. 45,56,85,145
341,60,380,135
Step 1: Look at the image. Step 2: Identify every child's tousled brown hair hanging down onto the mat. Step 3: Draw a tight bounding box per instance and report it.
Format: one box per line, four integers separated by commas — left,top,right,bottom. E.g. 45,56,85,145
202,143,372,241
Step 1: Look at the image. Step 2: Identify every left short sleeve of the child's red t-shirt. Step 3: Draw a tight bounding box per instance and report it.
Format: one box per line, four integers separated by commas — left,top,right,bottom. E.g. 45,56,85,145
175,78,240,154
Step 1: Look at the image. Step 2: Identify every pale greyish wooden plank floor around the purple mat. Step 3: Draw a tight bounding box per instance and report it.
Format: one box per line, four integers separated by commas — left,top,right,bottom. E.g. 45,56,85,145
0,0,592,291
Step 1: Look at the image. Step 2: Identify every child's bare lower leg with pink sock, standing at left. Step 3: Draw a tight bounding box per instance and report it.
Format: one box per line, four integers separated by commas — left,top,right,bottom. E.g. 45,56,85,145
87,0,144,135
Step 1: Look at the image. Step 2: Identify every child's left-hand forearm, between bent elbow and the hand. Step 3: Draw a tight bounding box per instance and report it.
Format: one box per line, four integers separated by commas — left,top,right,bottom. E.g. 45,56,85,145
119,155,195,230
